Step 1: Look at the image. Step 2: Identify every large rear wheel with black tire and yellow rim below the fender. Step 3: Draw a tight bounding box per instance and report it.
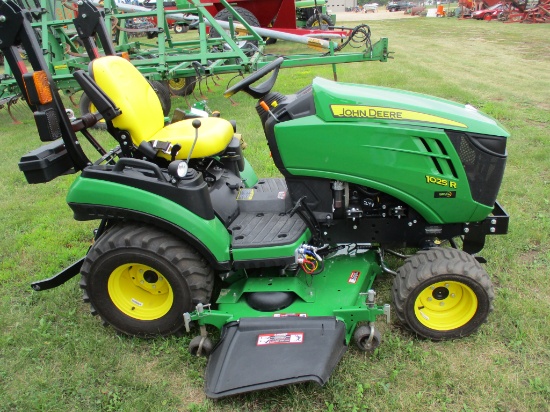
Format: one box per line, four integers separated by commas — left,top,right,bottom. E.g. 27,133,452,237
80,224,214,337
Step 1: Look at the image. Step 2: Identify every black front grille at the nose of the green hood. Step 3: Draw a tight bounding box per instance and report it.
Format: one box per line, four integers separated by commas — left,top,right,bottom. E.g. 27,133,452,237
447,131,506,206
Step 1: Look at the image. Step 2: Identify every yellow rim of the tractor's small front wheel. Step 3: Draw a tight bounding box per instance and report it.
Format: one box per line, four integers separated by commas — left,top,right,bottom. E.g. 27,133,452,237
414,281,478,331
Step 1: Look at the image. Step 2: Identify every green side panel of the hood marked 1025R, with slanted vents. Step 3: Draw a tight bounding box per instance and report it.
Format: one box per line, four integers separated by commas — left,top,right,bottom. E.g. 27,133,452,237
275,116,492,224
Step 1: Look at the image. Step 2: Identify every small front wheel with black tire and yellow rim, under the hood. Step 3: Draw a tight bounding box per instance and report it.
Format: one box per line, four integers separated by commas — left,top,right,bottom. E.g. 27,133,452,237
392,248,494,341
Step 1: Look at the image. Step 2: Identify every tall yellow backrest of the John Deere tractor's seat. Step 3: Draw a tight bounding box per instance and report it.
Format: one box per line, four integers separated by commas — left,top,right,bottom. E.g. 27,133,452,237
89,56,164,146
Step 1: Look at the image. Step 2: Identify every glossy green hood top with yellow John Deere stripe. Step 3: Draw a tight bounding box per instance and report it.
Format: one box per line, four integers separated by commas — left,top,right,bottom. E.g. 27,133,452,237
313,78,509,137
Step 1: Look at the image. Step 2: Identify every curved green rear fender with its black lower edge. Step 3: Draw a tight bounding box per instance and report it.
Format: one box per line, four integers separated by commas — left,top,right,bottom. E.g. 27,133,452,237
67,176,231,270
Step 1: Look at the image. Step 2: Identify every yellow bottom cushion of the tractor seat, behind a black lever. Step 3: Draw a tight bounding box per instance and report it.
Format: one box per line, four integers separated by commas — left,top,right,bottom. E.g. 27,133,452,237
149,117,234,160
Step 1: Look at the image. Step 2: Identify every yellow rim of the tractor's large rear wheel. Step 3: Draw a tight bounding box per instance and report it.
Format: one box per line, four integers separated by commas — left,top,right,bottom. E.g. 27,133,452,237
107,263,174,320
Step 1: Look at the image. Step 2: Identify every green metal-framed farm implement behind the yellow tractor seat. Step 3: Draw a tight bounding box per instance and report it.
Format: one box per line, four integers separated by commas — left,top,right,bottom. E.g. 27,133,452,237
0,0,388,121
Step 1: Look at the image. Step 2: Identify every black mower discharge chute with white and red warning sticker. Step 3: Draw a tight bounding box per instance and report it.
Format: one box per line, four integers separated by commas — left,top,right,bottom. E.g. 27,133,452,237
206,317,347,398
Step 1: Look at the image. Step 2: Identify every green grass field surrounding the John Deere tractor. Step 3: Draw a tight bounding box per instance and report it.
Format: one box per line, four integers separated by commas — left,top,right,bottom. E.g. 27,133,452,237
0,18,550,412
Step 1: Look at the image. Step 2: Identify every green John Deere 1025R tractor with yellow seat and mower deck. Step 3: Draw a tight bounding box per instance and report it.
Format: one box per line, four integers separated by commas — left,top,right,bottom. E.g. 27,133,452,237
0,1,508,398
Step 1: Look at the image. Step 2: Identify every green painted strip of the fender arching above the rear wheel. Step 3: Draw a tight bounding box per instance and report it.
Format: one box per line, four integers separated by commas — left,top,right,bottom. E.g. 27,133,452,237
67,176,231,262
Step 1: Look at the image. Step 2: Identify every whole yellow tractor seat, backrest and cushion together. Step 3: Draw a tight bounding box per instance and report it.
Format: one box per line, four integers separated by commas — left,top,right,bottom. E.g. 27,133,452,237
89,56,234,159
